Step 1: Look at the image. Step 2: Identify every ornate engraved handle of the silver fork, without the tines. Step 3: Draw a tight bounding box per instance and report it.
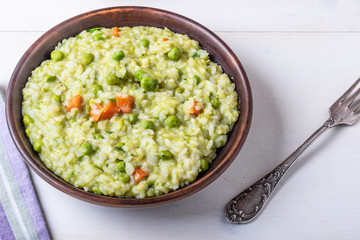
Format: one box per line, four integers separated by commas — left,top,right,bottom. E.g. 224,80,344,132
226,118,334,223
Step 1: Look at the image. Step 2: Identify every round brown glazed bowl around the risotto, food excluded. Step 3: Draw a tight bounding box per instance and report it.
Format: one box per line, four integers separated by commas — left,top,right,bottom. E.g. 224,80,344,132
6,7,252,207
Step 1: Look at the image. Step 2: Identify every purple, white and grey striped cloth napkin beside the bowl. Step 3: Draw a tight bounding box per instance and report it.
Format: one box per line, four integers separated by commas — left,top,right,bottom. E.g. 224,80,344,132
0,91,50,240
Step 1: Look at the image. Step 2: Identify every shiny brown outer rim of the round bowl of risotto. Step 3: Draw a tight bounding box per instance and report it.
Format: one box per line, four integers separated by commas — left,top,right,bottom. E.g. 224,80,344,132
6,6,253,208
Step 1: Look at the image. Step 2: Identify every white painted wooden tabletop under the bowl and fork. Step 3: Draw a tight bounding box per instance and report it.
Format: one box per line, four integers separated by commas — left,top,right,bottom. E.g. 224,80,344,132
0,0,360,240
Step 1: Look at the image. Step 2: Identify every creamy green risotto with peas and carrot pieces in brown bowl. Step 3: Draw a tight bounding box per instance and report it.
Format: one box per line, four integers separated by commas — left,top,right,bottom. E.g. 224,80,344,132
22,27,239,198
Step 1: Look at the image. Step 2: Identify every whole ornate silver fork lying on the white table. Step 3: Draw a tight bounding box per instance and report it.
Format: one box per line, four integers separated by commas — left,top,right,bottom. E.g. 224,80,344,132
226,78,360,223
